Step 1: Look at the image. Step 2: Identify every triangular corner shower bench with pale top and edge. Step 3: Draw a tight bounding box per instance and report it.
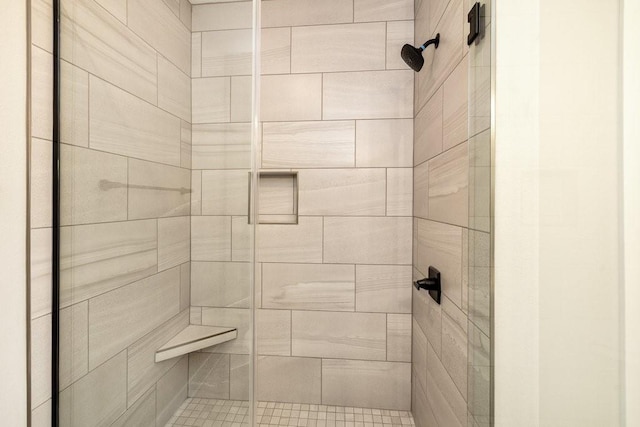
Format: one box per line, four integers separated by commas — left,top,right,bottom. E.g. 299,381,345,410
156,325,238,363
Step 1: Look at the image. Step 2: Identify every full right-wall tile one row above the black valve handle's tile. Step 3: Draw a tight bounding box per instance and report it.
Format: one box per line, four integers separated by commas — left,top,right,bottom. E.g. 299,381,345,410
429,143,469,227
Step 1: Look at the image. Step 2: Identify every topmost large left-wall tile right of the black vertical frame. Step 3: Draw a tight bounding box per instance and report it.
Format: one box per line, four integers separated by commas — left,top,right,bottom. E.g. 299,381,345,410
60,0,157,102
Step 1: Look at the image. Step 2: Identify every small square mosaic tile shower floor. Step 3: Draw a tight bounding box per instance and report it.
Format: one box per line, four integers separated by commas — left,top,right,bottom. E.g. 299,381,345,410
167,398,415,427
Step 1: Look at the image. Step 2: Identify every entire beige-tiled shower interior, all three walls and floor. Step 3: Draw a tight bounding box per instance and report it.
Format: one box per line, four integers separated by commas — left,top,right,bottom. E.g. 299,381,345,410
31,0,490,426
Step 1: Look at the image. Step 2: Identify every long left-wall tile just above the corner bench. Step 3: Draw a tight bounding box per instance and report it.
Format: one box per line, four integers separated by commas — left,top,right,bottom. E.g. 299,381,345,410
89,268,180,369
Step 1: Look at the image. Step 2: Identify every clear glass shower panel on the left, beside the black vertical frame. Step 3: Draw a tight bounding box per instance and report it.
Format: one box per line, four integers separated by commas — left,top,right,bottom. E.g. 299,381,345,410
53,0,257,426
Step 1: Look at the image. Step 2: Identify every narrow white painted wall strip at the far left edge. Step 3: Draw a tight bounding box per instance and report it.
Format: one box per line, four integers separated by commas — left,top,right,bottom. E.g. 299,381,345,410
0,0,27,426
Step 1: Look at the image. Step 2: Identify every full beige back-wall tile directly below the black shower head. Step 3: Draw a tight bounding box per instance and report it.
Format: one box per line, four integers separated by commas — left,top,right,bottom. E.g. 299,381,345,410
322,70,414,120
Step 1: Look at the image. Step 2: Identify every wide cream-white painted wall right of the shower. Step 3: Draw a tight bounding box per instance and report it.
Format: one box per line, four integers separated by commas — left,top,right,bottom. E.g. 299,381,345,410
495,0,623,427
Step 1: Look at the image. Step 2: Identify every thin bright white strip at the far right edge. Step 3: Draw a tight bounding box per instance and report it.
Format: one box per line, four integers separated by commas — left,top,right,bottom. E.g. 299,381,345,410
623,0,640,426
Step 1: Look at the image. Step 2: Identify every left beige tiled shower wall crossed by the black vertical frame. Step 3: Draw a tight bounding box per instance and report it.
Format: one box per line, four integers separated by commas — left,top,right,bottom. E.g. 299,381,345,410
31,0,191,426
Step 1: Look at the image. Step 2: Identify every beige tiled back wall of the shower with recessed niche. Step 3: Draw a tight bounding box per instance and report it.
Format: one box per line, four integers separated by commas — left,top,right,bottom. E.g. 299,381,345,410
189,0,414,410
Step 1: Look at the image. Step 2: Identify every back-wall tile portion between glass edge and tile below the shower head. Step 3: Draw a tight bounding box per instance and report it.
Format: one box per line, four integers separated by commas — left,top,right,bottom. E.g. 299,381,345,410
260,74,322,122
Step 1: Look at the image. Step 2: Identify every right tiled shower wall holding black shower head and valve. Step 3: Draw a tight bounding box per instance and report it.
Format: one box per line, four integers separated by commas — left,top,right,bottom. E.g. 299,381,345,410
412,0,490,427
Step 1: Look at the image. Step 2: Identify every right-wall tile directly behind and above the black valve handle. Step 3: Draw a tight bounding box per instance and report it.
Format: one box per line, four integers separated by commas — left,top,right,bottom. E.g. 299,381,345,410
417,219,462,307
